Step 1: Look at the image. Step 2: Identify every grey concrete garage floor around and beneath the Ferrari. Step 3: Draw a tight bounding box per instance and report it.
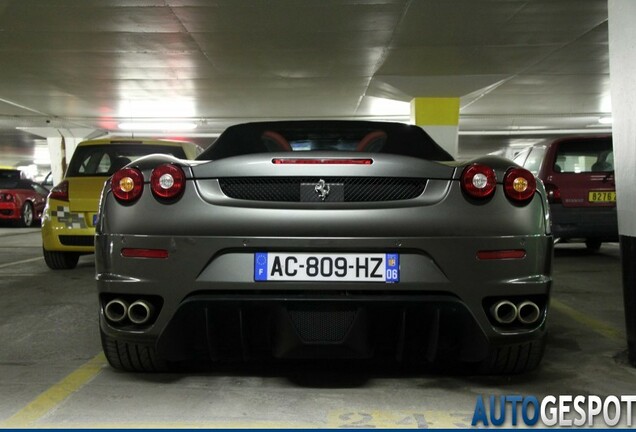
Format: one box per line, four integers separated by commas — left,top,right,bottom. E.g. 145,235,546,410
0,228,636,428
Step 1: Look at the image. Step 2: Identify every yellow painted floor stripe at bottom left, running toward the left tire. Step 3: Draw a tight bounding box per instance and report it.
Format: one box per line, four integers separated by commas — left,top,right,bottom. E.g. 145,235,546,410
0,353,106,428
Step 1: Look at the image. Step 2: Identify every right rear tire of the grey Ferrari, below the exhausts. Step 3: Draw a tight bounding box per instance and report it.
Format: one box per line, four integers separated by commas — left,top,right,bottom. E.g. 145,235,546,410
478,336,546,375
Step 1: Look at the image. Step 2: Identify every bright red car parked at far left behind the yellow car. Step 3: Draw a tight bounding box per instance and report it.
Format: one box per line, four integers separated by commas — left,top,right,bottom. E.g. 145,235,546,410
0,169,49,227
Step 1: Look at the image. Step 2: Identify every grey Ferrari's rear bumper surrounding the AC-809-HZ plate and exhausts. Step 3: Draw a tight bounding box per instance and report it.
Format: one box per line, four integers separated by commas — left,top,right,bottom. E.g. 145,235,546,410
96,234,552,361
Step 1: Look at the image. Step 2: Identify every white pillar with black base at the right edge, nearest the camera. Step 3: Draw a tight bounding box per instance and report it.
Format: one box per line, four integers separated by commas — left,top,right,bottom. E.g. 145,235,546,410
608,0,636,367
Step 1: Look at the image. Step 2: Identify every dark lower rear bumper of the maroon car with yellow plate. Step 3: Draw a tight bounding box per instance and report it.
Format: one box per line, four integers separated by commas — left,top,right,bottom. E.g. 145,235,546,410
550,204,618,241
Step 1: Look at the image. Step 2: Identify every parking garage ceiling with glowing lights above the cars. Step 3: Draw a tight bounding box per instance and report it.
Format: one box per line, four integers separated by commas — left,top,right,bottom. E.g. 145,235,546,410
0,0,610,159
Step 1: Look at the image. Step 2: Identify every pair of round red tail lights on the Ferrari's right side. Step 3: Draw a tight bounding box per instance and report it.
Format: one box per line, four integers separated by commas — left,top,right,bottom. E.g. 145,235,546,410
461,164,537,204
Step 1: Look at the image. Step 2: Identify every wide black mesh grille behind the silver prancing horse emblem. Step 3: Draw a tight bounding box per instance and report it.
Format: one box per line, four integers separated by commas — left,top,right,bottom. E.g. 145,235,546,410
219,177,426,202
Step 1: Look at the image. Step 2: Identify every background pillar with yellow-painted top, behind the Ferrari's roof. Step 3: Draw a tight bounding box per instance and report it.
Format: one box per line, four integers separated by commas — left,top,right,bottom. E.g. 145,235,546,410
411,97,459,158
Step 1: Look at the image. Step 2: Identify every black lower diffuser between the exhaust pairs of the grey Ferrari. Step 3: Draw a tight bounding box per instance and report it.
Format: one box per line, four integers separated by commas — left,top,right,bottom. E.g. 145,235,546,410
152,293,520,362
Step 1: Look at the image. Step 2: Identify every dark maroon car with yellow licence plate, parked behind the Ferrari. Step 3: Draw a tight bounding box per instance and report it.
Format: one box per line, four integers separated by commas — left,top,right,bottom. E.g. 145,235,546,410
514,135,618,250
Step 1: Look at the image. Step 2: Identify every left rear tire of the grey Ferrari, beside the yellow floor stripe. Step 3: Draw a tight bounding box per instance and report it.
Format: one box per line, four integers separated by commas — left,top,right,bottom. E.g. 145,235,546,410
100,329,170,372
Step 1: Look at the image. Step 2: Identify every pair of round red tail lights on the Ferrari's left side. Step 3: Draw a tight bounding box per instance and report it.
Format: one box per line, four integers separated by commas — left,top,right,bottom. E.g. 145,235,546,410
110,164,185,204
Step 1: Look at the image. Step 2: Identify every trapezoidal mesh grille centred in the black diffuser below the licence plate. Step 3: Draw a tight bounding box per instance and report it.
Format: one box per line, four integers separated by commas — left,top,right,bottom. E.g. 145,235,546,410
289,310,357,343
